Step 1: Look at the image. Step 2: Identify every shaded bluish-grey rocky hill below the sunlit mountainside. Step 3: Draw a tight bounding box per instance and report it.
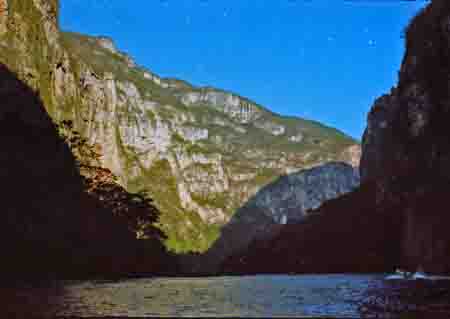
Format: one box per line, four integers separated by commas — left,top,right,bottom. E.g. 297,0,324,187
183,163,359,274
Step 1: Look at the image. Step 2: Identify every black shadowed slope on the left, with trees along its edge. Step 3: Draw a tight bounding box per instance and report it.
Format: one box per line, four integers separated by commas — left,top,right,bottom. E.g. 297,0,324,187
0,64,170,280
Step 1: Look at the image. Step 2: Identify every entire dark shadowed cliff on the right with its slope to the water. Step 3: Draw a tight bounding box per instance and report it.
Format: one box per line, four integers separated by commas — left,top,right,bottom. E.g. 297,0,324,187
223,0,450,274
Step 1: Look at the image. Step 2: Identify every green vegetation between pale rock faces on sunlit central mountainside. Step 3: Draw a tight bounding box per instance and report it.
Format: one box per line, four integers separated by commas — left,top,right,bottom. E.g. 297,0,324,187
55,28,355,252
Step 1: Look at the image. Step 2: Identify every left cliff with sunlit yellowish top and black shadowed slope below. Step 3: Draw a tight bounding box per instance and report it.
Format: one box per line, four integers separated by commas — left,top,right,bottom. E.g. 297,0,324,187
0,0,174,279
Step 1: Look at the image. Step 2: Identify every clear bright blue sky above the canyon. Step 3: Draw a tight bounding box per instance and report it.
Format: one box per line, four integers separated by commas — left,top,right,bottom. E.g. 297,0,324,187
60,0,424,138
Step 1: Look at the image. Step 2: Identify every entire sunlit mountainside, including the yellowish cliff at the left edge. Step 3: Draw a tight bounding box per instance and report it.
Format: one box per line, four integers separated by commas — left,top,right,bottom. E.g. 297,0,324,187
0,0,359,252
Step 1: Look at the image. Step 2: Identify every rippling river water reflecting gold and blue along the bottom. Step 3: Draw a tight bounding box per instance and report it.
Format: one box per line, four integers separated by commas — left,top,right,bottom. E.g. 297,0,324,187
0,275,450,318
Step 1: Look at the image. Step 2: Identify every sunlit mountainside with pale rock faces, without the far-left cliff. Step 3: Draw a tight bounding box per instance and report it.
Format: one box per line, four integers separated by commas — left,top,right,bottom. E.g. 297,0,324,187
54,33,356,250
